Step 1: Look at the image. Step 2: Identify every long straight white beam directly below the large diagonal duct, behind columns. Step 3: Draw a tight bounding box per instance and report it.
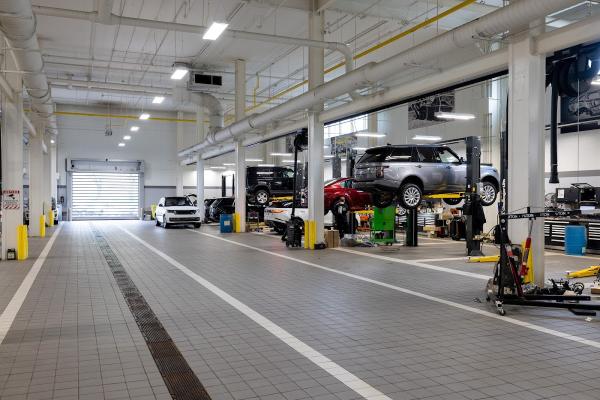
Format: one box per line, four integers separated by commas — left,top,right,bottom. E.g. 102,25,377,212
202,9,600,159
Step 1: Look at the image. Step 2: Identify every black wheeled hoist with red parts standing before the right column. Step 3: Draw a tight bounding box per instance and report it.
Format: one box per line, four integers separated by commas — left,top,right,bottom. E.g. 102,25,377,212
486,210,600,315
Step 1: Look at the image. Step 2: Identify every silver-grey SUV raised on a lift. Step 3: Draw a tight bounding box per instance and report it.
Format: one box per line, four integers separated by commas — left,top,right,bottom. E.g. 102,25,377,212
353,145,500,209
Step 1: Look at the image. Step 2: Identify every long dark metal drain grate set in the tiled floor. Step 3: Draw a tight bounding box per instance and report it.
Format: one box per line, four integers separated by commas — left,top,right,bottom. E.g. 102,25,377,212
91,226,211,400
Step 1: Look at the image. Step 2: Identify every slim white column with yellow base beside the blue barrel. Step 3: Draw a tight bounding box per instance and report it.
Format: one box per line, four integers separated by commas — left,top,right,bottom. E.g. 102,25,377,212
235,60,246,232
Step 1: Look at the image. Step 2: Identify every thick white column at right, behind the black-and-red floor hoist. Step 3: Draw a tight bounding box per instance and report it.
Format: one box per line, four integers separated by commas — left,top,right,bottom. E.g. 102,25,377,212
508,28,546,285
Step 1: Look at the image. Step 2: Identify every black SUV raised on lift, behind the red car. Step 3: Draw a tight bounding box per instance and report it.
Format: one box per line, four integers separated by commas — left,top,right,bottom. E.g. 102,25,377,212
246,167,294,206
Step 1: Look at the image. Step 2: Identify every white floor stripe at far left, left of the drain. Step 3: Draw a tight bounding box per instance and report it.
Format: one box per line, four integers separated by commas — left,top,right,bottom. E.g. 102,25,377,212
0,225,62,344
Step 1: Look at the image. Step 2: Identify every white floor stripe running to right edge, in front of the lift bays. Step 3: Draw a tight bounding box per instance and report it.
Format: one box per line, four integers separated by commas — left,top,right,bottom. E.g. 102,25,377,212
188,228,600,349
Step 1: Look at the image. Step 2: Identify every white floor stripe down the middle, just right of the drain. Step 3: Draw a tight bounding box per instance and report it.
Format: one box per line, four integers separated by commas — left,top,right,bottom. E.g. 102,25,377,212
119,226,391,400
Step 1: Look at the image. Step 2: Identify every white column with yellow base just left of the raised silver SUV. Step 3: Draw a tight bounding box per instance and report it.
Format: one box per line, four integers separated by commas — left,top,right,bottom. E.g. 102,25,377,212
308,7,325,248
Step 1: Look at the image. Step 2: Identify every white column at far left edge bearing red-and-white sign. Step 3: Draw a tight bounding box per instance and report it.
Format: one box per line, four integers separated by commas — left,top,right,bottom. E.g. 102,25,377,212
0,53,23,259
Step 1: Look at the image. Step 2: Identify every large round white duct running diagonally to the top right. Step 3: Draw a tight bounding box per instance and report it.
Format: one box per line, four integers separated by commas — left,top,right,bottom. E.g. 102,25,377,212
178,0,578,157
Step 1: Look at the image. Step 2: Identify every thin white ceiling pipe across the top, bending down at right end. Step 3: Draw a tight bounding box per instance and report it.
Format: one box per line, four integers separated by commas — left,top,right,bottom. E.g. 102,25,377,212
33,6,354,82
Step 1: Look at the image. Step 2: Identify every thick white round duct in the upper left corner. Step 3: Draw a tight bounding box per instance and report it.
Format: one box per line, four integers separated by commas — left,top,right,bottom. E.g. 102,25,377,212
0,0,58,134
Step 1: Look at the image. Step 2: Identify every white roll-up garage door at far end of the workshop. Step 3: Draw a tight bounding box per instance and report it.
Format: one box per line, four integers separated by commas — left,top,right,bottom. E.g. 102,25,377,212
71,172,140,220
